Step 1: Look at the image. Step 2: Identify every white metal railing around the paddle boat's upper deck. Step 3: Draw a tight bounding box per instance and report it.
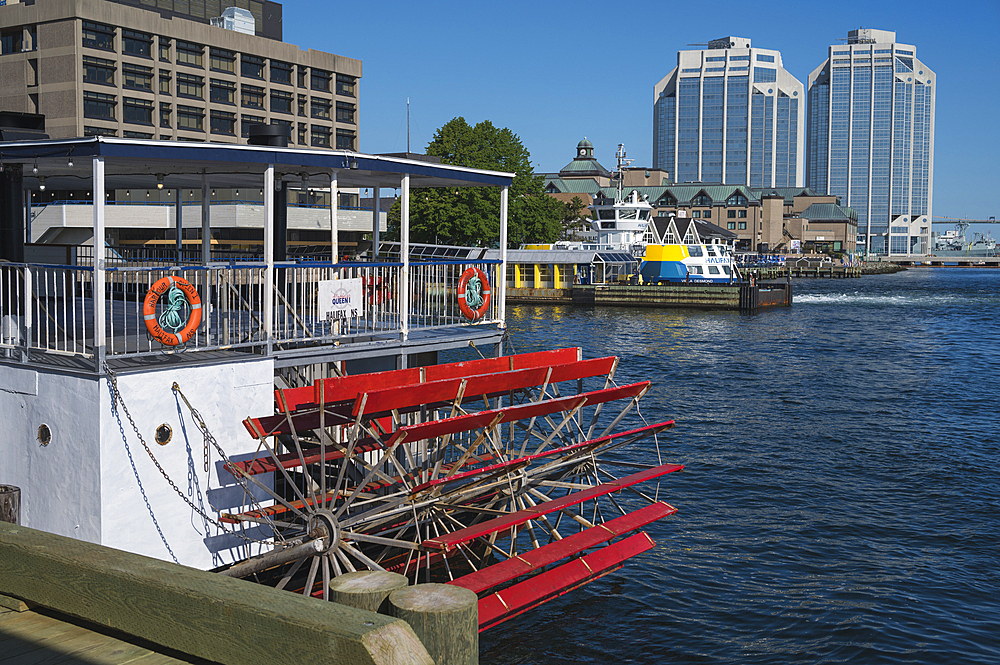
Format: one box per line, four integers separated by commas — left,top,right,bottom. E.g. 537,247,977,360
0,261,503,362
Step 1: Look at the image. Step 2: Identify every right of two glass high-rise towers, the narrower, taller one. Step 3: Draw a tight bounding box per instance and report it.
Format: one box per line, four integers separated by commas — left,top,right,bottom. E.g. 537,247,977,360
806,29,935,254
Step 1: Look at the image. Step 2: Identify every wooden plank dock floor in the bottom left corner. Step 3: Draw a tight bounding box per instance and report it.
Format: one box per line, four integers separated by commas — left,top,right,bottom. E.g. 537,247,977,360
0,607,212,665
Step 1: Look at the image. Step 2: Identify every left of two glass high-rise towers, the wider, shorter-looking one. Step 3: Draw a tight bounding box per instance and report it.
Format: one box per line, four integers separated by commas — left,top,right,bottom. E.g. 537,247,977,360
653,37,805,187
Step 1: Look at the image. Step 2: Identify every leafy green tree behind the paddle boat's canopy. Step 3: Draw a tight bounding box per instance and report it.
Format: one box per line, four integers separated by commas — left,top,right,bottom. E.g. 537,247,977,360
388,117,565,247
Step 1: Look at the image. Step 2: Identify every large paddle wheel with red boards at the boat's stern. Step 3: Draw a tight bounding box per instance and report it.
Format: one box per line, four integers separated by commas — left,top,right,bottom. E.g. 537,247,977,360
223,348,683,630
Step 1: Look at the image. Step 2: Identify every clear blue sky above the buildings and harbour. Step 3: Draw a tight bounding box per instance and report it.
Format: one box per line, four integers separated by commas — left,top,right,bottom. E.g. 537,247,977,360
283,0,1000,239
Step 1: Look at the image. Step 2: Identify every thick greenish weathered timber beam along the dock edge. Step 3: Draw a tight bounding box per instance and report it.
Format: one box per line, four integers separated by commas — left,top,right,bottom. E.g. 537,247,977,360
0,522,433,665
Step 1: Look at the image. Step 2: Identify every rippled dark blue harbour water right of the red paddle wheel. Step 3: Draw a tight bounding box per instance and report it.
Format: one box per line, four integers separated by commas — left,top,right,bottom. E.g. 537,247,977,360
481,268,1000,663
